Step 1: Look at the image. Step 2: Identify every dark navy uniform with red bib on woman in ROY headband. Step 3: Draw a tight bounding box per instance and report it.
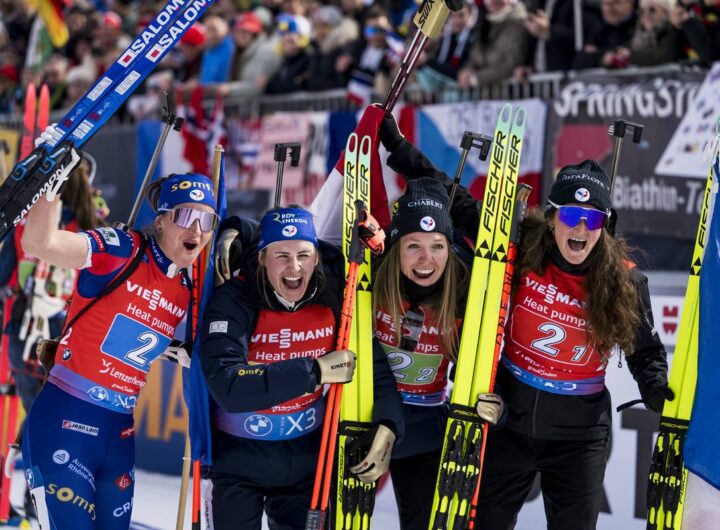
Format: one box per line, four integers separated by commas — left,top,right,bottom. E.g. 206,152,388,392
201,217,402,530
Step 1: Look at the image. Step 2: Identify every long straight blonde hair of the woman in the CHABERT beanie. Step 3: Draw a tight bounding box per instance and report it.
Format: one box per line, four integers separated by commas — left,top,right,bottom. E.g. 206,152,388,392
373,242,467,362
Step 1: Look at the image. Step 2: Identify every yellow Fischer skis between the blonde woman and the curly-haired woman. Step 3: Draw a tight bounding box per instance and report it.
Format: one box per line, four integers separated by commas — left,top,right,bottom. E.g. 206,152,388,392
430,104,526,530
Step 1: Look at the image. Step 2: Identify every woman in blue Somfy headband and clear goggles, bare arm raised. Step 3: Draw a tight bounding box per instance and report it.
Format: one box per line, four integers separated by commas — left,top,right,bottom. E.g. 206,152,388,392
22,155,217,530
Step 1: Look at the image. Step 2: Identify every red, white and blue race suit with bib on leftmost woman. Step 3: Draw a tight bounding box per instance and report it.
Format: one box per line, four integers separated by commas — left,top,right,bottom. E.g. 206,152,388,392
22,228,190,530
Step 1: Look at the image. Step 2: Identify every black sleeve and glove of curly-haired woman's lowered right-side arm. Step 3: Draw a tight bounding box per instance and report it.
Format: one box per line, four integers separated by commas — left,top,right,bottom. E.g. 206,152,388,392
626,270,668,392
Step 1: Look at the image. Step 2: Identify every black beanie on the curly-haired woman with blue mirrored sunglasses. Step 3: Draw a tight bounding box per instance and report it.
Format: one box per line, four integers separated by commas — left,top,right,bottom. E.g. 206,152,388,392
548,160,612,212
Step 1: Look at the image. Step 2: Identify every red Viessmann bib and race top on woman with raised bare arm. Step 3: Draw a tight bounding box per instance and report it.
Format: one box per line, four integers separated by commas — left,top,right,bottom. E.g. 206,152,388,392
48,228,190,414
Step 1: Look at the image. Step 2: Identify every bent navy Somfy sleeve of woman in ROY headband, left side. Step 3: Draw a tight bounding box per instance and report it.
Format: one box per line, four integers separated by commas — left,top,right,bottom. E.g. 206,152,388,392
200,282,317,412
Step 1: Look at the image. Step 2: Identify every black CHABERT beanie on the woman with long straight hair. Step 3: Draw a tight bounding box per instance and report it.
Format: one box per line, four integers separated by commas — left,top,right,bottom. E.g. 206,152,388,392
388,177,452,246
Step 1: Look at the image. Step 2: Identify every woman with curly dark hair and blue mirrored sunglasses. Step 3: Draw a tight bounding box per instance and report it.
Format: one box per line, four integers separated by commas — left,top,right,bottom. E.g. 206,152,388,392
380,118,674,530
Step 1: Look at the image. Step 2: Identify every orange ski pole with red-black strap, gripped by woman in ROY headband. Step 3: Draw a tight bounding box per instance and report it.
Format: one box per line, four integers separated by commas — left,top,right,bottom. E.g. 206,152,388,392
305,201,385,530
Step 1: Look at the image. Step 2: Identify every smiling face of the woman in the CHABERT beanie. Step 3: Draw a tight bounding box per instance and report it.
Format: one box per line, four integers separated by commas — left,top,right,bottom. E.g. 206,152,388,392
398,232,449,287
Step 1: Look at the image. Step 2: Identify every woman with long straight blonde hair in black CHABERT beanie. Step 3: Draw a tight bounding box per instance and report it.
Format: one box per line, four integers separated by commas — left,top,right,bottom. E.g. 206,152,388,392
373,175,503,530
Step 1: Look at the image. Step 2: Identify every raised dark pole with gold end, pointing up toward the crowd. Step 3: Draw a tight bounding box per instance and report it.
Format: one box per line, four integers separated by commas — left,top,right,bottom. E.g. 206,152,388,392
382,0,463,114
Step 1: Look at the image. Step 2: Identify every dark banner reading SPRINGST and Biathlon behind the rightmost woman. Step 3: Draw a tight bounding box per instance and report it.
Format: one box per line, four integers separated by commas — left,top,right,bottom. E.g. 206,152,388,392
544,72,704,239
